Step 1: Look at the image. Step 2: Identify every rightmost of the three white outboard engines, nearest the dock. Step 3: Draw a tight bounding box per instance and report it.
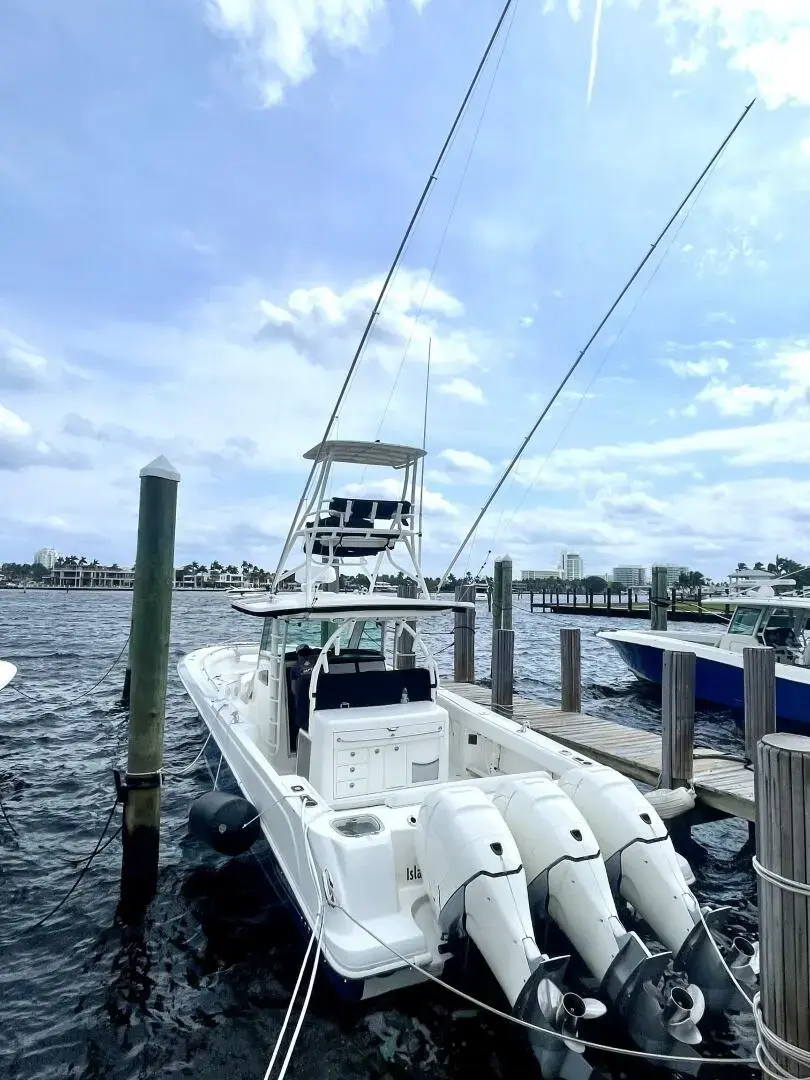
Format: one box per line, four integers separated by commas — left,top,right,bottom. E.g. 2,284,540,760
558,765,758,1010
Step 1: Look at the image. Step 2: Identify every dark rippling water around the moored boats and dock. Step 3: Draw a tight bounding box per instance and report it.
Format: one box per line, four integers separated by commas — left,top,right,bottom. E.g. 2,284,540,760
0,591,756,1080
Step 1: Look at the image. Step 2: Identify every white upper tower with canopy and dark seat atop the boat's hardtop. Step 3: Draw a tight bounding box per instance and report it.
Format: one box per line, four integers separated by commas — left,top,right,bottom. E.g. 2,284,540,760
273,438,430,605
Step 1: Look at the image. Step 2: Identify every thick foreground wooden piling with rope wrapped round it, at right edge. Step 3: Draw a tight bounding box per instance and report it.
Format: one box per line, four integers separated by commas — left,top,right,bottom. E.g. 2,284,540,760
754,732,810,1077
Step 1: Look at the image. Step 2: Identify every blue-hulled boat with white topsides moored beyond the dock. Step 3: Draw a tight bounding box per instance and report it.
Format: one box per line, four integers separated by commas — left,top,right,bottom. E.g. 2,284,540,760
598,584,810,731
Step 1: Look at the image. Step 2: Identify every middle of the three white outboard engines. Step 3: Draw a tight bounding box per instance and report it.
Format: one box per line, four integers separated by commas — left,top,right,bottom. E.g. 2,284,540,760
492,777,703,1053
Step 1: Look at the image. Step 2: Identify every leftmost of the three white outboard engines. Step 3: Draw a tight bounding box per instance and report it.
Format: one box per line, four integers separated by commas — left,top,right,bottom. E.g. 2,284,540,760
415,784,605,1080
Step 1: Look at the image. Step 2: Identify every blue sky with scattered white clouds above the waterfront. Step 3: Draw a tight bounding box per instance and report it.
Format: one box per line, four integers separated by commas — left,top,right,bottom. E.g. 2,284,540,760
0,0,810,577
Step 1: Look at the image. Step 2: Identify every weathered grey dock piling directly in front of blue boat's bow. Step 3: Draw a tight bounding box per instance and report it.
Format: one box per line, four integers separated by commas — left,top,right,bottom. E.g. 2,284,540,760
661,649,694,787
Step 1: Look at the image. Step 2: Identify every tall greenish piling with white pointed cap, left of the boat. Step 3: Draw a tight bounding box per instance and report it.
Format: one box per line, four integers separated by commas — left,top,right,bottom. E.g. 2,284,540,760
121,457,180,907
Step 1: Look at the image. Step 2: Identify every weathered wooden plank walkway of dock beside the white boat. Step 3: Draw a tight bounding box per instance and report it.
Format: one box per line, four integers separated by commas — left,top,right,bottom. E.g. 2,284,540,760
442,681,755,822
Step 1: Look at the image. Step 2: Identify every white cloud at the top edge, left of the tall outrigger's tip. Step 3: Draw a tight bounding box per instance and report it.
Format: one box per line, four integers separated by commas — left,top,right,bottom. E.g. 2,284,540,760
206,0,428,107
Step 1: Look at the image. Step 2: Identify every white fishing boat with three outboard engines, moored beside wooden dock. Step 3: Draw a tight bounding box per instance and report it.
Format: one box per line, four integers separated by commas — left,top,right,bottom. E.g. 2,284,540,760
179,440,757,1078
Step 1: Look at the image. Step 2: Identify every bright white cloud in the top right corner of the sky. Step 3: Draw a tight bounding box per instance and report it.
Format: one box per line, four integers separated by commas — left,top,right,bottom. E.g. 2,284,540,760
659,0,810,108
